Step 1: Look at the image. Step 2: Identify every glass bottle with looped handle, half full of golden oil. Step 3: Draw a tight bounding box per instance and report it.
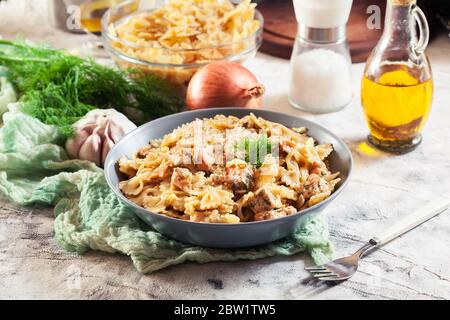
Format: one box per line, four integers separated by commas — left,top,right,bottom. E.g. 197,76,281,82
361,0,433,153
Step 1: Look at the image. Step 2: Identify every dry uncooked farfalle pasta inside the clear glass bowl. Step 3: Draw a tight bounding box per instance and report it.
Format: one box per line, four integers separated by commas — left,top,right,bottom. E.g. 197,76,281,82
109,0,260,84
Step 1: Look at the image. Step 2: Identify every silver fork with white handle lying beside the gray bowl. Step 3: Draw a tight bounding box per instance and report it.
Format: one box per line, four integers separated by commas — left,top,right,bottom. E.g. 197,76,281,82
305,200,450,281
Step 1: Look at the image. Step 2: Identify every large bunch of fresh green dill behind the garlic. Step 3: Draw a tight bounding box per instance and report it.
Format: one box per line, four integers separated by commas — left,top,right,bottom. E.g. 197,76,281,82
0,40,184,137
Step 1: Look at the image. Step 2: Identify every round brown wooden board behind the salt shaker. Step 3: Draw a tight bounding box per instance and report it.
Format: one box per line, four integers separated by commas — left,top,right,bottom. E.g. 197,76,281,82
258,0,386,62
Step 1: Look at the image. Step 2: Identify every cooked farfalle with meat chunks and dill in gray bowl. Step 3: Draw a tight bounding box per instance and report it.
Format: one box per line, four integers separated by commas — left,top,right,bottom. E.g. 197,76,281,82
119,114,340,223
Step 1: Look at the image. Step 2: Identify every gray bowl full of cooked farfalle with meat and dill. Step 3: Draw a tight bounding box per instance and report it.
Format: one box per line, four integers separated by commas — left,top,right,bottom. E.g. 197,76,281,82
104,108,352,248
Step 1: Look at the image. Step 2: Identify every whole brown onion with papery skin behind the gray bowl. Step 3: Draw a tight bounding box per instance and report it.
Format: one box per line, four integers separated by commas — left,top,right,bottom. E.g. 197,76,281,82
186,61,264,110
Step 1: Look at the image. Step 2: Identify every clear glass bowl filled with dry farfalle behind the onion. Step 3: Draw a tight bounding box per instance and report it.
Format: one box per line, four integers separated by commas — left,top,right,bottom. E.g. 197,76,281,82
102,0,263,93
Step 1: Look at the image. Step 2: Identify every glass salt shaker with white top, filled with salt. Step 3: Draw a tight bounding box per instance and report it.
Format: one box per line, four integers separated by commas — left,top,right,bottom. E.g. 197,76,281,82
289,0,353,113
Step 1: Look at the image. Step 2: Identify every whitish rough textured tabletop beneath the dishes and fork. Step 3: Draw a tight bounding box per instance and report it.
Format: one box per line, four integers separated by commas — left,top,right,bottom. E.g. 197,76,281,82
0,0,450,299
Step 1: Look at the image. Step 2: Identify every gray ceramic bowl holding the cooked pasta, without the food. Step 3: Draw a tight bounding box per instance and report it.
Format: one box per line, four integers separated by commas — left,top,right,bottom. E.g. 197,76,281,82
105,108,352,248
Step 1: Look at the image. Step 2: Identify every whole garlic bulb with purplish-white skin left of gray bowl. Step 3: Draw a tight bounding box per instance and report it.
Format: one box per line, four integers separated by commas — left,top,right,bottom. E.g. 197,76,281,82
66,109,136,166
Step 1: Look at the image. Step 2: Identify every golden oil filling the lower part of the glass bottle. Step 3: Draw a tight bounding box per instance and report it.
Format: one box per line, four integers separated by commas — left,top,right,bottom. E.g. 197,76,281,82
361,66,433,144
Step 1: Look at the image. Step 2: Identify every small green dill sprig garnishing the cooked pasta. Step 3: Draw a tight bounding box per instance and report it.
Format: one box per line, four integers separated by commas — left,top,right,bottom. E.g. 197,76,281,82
234,134,272,167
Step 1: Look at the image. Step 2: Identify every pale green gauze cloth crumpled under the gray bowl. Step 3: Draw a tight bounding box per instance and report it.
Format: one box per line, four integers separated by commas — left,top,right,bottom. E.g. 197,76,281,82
0,79,332,273
